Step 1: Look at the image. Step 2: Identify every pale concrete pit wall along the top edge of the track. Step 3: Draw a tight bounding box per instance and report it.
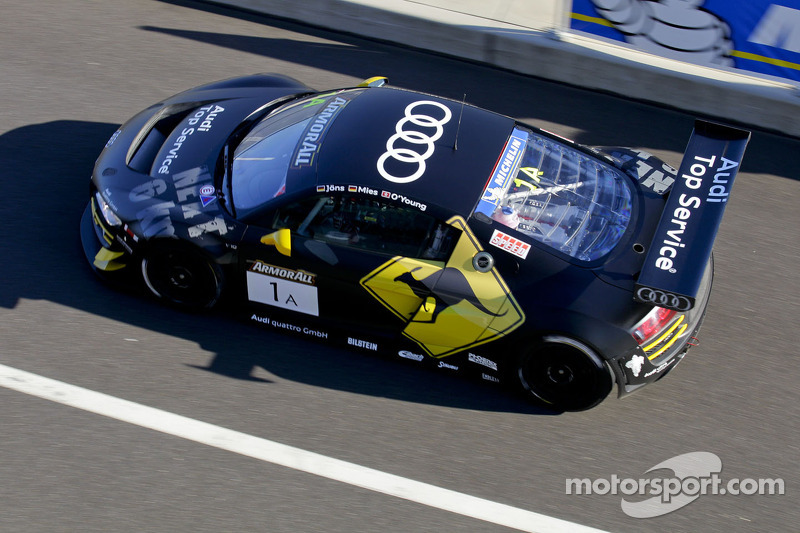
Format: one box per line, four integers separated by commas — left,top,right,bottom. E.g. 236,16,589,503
203,0,800,136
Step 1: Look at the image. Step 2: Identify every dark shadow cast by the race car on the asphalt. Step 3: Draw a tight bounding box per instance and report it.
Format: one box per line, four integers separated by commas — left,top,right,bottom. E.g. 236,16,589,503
0,120,557,415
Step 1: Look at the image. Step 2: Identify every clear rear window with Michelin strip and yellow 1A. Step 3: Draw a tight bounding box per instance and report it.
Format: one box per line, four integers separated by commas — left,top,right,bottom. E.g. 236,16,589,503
475,128,631,261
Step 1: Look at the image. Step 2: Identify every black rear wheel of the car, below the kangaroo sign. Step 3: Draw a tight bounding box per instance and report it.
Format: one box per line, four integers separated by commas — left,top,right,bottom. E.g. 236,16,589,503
517,336,614,411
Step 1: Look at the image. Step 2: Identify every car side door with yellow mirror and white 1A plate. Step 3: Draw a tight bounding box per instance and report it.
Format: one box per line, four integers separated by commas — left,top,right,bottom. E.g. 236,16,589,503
239,191,460,337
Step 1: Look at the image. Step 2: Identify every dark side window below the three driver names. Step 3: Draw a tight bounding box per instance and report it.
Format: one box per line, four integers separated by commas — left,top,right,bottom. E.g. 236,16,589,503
272,194,458,260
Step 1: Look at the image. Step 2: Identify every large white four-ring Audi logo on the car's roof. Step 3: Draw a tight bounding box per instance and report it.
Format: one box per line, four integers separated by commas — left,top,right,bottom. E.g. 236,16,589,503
378,100,453,183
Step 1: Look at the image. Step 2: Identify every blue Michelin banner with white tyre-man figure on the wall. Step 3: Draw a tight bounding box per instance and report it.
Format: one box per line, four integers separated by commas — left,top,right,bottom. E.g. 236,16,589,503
570,0,800,82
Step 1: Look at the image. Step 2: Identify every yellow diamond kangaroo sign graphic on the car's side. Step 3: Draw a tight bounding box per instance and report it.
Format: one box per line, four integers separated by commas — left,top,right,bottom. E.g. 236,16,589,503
361,217,525,358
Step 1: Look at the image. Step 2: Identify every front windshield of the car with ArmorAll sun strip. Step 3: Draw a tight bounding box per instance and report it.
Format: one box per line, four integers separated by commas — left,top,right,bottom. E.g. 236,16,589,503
231,93,352,218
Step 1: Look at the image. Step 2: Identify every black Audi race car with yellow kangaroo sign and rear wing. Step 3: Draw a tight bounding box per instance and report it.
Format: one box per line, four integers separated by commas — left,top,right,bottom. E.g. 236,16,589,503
81,74,750,410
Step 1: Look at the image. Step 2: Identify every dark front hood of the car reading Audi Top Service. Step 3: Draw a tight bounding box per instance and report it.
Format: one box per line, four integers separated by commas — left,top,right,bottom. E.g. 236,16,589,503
92,87,310,238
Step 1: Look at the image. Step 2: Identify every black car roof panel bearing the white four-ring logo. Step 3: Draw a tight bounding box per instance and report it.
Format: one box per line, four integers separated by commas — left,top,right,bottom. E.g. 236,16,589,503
314,87,515,217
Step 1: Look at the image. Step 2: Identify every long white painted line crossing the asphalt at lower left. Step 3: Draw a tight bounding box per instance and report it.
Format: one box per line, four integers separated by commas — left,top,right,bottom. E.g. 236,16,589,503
0,364,604,533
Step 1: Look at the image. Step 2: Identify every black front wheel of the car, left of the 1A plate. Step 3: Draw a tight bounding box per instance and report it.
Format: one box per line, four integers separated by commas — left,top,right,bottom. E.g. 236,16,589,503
142,245,224,311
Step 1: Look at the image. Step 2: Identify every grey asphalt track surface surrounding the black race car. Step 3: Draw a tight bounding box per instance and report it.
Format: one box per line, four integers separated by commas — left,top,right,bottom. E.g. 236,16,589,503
0,0,800,533
